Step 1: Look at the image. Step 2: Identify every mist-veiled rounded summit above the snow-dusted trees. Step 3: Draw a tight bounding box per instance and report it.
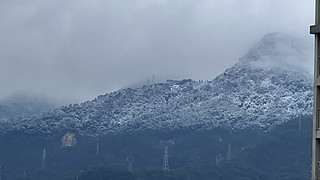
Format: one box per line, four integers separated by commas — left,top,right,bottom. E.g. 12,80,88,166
240,33,309,73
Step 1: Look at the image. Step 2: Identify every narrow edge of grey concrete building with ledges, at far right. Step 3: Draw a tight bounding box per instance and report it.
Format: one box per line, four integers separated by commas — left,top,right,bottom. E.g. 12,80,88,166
310,0,320,180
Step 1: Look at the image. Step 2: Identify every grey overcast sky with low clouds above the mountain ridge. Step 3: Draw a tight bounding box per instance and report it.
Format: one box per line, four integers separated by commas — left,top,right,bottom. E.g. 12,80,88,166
0,0,314,102
